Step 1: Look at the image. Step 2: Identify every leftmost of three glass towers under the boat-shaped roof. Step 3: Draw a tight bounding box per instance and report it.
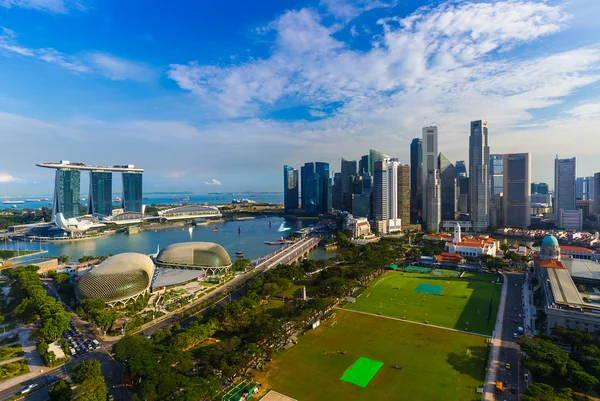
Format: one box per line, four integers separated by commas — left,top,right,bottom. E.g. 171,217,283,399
52,168,81,219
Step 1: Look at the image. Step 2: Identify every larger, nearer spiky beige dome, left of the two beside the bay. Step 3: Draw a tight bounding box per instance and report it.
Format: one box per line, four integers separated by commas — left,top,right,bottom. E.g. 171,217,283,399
75,253,154,307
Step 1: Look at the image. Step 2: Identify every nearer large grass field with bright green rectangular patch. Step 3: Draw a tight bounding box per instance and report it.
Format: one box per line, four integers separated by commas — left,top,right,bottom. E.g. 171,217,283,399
256,310,487,401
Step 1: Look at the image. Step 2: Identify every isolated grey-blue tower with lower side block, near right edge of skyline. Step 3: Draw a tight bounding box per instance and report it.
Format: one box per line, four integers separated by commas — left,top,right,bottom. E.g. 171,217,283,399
554,157,577,227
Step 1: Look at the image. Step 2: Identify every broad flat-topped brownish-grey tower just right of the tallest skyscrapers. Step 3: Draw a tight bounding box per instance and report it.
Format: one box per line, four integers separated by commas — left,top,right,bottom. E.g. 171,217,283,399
502,153,531,228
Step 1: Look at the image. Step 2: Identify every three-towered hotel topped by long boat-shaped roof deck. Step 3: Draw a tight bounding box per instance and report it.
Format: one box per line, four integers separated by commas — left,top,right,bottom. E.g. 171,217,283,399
37,160,144,219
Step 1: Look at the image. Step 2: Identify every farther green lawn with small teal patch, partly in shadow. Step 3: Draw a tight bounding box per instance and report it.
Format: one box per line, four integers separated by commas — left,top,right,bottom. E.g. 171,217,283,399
345,272,502,335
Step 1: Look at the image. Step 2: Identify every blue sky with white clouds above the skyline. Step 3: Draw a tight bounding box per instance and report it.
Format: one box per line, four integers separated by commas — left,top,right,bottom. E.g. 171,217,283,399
0,0,600,196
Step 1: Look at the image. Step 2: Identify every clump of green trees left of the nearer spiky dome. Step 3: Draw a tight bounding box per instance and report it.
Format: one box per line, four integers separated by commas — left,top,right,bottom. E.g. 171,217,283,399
6,266,71,341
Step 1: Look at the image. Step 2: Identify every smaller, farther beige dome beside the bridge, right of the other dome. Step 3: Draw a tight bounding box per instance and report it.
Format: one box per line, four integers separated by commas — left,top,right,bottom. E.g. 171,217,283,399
156,242,231,274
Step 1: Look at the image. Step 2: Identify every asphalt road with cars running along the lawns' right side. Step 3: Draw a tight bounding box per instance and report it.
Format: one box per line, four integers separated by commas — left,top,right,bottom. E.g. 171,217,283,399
496,273,525,401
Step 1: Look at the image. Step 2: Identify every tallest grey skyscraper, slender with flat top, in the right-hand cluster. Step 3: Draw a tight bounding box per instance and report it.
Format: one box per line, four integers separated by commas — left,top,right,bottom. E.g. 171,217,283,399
469,120,490,232
